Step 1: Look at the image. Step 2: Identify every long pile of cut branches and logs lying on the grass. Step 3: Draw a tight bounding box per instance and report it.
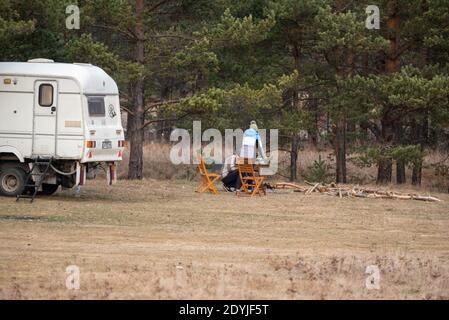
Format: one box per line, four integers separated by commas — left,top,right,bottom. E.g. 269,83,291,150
272,182,441,201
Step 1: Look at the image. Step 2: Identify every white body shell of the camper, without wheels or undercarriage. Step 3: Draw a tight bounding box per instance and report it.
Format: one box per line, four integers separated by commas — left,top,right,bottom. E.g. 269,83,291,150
0,62,124,163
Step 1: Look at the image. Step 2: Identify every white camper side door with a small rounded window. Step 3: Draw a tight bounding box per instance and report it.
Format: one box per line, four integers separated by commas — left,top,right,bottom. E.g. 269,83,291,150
33,81,58,157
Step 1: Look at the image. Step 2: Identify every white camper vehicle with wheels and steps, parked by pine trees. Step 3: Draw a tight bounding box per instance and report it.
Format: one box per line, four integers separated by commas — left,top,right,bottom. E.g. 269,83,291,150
0,59,125,198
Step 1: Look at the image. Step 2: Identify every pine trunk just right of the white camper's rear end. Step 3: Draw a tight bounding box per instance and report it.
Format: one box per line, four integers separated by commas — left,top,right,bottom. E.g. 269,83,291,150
128,0,145,179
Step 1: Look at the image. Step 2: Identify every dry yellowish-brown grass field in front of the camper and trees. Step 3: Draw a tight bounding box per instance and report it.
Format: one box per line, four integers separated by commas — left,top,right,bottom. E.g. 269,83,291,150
0,180,449,299
